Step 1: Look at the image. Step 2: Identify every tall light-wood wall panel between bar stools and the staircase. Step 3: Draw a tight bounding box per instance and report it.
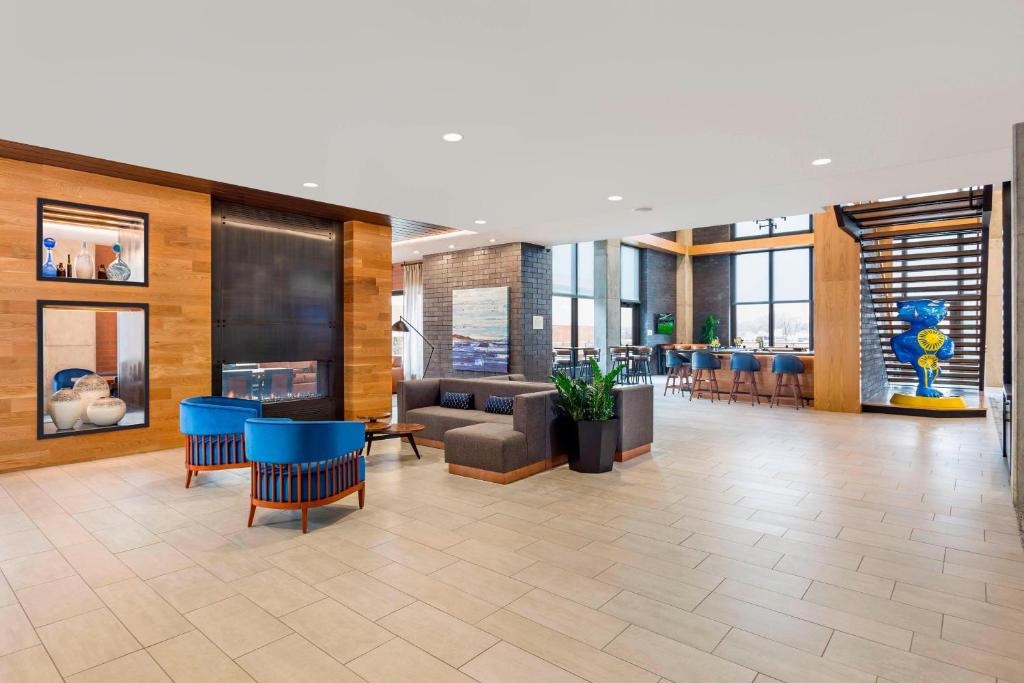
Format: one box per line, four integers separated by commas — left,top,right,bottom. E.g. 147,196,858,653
814,208,860,413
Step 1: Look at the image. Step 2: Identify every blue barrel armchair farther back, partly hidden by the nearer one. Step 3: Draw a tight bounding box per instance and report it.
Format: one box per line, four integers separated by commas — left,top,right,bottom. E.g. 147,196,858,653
178,396,262,488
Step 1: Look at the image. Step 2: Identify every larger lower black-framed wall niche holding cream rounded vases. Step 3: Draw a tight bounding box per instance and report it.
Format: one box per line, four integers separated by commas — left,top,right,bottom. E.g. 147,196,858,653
36,300,150,439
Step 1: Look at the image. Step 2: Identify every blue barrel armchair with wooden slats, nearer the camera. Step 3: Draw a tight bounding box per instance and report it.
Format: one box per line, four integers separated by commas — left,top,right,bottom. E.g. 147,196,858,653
245,418,367,533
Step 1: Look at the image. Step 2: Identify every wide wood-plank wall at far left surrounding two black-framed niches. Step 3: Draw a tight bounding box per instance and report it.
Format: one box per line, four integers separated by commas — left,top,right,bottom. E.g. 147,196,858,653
0,159,211,471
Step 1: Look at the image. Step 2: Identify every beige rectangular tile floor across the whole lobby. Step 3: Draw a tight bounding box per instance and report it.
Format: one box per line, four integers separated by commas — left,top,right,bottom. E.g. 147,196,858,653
0,387,1024,683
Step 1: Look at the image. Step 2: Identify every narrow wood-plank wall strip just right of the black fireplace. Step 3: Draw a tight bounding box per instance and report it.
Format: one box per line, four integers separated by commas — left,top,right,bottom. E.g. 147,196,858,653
342,221,392,420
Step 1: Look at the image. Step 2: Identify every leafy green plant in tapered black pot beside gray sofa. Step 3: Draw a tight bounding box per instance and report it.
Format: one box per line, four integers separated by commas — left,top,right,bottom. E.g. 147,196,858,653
551,359,623,473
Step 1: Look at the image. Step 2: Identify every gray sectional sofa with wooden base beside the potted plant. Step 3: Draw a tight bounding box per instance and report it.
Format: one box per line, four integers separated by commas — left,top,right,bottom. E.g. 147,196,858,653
398,375,654,483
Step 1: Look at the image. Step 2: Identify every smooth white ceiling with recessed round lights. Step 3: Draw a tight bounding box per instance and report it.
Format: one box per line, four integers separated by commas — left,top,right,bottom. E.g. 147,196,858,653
0,0,1024,260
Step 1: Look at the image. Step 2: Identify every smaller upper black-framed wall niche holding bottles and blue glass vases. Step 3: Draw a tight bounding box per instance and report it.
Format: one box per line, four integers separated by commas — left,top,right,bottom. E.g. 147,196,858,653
36,198,150,287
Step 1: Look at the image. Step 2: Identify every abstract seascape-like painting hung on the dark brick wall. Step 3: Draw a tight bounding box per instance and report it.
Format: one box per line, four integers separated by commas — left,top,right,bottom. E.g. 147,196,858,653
452,287,509,373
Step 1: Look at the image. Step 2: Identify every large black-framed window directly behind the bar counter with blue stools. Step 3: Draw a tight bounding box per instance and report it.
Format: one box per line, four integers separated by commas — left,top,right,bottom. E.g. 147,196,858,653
732,247,813,348
